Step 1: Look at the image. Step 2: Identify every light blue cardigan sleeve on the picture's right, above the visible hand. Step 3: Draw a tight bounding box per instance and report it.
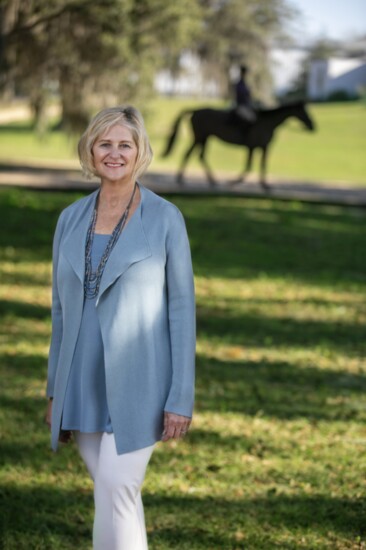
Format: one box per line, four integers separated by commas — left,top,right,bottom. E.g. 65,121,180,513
164,210,196,417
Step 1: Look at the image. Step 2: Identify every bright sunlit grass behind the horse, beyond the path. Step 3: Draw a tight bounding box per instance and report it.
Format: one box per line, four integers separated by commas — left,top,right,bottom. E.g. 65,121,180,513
0,98,366,185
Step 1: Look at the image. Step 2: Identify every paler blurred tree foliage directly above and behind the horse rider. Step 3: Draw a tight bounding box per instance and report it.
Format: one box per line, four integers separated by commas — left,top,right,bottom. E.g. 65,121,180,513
197,0,295,101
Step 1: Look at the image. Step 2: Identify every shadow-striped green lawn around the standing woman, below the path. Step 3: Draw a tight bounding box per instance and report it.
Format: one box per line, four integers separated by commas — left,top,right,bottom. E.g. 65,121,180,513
0,190,366,550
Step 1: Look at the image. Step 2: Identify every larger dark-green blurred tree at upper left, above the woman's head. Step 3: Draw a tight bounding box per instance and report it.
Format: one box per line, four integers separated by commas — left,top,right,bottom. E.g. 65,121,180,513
0,0,198,131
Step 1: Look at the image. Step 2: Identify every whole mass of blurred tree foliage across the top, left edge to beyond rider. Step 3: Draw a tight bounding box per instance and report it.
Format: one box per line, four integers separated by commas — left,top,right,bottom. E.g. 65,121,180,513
0,0,289,130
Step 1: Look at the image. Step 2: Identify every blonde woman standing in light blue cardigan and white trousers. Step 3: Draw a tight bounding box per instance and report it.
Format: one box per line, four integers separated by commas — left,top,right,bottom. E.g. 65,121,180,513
46,106,195,550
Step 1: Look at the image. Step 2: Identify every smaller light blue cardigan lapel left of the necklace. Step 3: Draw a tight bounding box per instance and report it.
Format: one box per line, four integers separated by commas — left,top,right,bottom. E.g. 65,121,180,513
62,191,98,284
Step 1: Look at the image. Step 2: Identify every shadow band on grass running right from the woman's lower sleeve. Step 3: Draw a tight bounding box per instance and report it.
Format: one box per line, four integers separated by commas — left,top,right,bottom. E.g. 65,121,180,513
196,357,366,422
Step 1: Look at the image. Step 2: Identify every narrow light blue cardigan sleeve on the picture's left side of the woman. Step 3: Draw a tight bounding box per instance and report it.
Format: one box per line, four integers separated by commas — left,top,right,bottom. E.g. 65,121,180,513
46,214,63,397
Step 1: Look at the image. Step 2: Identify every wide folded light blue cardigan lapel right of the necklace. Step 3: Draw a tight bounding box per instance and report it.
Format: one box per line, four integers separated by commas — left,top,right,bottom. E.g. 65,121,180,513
97,185,152,304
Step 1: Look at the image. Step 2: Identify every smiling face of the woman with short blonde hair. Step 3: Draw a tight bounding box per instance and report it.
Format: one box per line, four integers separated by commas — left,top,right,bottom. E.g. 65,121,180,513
92,124,137,183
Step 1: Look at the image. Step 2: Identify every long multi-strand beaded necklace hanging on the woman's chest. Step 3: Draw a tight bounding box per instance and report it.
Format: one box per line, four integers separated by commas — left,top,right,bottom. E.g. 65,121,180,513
84,183,137,300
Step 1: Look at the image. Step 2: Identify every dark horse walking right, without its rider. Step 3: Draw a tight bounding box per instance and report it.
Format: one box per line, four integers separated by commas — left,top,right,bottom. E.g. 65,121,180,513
162,101,315,190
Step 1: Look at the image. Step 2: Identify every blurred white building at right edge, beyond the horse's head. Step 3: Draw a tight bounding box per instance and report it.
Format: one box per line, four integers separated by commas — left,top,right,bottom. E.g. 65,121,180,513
307,58,366,100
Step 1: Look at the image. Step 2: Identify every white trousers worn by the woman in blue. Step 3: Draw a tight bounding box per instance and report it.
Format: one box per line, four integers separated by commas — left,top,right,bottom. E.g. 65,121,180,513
74,432,155,550
